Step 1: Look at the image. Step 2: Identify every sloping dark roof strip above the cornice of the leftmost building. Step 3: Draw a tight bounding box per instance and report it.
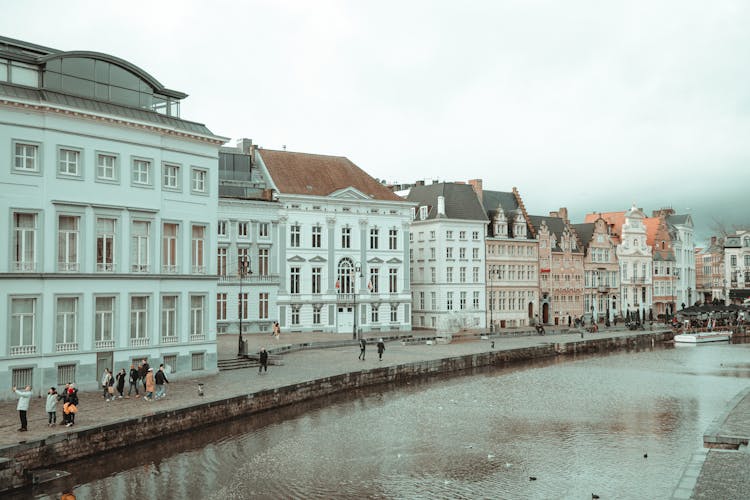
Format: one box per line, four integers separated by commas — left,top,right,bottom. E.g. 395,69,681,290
0,83,214,135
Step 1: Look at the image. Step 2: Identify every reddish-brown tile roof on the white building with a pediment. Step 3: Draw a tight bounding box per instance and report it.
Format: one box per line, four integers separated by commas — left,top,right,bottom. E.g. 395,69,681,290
258,149,404,201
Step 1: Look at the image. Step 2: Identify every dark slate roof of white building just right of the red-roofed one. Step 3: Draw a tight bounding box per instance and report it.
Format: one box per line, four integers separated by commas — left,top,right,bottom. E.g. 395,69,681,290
406,182,487,222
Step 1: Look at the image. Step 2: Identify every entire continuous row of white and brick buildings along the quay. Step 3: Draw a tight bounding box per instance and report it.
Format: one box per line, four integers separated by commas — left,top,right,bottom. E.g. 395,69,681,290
0,37,694,397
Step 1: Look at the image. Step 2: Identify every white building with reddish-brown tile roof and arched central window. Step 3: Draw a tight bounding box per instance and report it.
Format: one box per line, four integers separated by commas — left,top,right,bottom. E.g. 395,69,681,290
255,149,413,338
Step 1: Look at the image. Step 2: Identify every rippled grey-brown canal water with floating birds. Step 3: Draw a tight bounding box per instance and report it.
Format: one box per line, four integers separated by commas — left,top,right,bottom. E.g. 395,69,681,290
33,343,750,500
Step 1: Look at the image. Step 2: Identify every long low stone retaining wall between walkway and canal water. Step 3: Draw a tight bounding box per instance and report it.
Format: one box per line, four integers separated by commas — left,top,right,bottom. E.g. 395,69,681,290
0,332,674,491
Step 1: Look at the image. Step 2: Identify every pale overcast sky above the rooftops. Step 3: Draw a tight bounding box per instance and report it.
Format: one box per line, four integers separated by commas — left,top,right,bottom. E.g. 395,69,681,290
0,0,750,242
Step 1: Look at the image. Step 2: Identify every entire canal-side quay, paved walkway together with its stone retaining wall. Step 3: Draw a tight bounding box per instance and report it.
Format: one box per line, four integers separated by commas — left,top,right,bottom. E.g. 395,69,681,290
0,329,744,496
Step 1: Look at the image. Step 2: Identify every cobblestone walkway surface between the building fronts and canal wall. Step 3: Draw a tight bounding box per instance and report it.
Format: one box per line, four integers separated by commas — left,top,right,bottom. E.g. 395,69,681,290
0,329,648,446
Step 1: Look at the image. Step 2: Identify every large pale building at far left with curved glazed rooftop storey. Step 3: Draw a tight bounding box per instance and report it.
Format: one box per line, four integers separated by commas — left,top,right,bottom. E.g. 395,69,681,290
0,39,225,393
